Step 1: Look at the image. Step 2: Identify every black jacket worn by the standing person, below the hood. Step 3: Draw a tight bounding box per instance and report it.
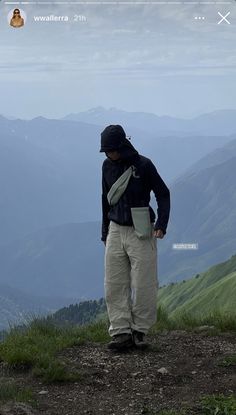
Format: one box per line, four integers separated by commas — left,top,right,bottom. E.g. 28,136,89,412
101,149,170,241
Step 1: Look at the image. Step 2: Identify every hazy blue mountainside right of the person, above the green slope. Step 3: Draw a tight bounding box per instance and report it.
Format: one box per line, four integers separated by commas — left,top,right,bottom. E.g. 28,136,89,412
159,156,236,281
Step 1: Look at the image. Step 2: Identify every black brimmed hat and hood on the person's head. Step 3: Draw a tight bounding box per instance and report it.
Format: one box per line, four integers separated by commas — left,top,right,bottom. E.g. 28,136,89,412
100,125,138,159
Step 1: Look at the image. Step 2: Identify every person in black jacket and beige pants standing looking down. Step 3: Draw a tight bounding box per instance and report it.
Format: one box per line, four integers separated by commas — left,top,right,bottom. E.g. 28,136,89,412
100,125,170,350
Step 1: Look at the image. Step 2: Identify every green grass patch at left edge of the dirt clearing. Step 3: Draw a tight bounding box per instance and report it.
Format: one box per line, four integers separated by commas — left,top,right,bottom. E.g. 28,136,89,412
0,318,110,383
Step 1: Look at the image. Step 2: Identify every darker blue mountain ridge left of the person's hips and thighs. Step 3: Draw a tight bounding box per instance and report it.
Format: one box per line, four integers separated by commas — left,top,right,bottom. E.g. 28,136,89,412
0,222,104,299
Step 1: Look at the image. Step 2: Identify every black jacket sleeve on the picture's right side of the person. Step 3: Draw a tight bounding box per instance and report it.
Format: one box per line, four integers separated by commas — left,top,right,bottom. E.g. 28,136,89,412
148,160,170,235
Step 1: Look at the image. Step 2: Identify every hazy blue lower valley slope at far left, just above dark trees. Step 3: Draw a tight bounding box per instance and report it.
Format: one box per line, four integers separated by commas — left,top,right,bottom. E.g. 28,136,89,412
0,283,79,330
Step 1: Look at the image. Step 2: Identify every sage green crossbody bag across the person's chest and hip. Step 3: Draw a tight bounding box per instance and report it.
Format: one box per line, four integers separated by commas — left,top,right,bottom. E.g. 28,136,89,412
107,166,153,239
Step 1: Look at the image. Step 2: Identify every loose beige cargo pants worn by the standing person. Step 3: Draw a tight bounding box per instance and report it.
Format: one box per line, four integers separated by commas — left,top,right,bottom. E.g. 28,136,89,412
104,221,158,336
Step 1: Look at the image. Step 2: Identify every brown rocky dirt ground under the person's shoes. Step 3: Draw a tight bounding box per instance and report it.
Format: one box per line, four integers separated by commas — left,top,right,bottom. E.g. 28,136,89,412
0,331,236,415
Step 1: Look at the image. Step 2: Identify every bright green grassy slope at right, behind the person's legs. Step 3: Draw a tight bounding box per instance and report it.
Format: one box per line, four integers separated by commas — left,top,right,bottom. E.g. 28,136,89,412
158,255,236,313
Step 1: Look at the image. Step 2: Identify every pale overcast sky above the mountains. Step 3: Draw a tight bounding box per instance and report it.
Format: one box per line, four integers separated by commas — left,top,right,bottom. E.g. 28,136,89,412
0,1,236,118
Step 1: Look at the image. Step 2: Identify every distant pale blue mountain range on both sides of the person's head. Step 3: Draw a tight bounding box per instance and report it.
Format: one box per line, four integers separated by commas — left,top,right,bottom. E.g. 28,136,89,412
0,112,235,245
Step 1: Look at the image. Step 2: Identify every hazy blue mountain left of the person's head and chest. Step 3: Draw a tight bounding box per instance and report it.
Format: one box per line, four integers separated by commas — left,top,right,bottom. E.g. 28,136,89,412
0,119,102,244
